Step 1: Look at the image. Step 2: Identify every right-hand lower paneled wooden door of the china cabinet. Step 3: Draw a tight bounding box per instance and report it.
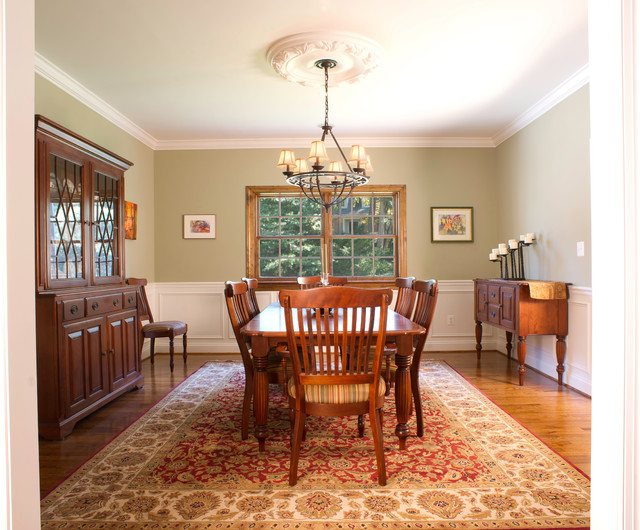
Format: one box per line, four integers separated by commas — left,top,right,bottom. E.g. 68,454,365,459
107,310,140,391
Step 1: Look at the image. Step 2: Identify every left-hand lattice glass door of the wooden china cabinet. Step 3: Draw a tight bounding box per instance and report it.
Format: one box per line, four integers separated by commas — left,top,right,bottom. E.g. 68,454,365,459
47,153,84,283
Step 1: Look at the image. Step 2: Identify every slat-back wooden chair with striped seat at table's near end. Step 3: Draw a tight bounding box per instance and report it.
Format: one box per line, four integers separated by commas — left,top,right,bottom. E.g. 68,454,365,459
280,286,392,486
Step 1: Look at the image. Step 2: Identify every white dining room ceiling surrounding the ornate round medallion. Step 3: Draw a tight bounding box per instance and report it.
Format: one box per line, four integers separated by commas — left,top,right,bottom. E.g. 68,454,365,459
35,0,588,148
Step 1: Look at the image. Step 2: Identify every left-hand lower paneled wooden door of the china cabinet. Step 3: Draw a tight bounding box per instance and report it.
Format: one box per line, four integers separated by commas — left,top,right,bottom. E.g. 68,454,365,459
62,318,109,418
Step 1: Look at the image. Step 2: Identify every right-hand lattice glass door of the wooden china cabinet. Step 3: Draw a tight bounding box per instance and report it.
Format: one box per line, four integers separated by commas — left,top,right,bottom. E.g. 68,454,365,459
92,171,120,280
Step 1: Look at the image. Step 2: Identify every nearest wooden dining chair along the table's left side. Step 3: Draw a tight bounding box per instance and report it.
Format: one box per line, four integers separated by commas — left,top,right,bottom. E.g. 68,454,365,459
224,281,286,440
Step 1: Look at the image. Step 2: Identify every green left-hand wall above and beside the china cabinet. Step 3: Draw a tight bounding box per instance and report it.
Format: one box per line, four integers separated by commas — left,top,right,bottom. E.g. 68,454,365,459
35,75,155,281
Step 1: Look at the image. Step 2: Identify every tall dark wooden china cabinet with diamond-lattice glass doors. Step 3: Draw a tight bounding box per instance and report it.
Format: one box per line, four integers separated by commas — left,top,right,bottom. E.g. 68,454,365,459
35,116,143,440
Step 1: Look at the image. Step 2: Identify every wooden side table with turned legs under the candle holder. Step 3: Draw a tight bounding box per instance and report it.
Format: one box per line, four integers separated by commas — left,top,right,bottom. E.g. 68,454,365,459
474,279,571,385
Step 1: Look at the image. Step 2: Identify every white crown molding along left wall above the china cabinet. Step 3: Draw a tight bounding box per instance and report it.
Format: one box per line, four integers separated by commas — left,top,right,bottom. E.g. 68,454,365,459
35,52,158,149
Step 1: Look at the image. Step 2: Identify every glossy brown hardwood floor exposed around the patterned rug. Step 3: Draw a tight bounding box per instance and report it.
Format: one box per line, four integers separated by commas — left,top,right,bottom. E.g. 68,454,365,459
40,351,591,495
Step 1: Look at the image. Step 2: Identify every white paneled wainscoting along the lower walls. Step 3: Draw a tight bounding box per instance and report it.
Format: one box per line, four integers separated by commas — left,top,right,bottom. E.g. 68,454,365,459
143,280,591,395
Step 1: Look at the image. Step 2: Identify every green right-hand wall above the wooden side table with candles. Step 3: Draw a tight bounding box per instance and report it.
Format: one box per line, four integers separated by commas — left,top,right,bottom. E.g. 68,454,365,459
493,86,591,287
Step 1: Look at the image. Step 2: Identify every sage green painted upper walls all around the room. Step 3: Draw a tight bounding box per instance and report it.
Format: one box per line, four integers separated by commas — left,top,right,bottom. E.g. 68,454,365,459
35,75,591,286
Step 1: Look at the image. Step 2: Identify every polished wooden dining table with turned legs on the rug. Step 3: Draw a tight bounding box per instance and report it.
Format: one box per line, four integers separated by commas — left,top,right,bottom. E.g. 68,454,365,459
240,302,425,451
